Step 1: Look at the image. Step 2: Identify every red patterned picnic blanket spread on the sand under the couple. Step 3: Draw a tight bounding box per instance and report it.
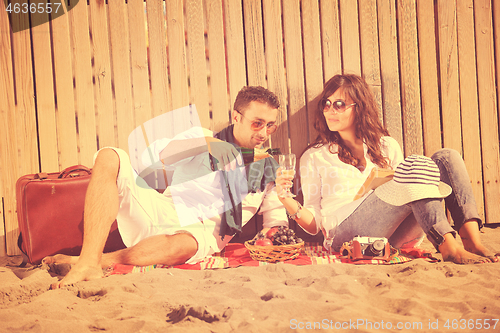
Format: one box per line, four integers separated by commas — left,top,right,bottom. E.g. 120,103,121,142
106,243,438,276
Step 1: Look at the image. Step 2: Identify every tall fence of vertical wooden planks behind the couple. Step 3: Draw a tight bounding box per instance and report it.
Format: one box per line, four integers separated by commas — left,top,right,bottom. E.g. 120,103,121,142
0,0,500,255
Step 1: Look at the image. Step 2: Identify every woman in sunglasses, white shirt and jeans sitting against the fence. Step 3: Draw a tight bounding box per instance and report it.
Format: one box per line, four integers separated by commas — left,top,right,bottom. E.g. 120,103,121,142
276,75,498,264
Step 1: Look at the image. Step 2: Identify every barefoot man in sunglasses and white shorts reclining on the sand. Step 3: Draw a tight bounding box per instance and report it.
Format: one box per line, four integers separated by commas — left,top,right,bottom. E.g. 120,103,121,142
44,87,288,288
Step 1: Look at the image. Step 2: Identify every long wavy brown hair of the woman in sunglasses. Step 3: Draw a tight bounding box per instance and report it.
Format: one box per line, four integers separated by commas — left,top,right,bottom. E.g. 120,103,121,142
306,74,389,168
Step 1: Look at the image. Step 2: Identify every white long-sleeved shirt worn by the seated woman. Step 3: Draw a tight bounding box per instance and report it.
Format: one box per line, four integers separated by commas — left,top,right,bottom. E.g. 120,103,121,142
300,136,404,242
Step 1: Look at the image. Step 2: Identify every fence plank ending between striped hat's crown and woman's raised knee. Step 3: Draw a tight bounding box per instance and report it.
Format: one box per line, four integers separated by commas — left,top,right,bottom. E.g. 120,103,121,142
417,0,442,156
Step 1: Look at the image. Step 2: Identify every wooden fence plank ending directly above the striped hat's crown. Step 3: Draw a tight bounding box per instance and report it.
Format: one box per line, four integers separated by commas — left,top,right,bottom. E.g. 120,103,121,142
397,0,424,155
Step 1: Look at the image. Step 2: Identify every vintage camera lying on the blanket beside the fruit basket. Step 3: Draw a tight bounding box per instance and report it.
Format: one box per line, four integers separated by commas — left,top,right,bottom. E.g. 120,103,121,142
340,236,391,260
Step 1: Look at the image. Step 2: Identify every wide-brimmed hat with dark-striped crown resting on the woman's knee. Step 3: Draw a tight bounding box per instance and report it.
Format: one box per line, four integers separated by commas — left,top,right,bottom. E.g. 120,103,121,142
375,155,451,206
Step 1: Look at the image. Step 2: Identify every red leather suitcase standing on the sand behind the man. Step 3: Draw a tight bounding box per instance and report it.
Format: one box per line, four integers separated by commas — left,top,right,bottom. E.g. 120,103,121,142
16,165,125,265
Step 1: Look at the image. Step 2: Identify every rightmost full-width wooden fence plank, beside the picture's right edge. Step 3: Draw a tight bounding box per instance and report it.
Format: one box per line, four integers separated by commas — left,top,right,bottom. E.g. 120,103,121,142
474,0,500,223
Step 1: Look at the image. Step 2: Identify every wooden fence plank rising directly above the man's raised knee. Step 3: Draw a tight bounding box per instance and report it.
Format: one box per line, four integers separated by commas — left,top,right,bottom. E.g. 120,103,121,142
89,0,118,149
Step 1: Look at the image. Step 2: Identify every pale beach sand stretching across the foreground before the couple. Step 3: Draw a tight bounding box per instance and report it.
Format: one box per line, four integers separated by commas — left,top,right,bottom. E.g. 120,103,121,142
0,227,500,333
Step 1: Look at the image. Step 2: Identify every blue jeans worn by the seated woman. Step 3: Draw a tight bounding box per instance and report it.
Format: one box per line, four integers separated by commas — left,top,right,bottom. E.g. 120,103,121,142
331,149,482,251
